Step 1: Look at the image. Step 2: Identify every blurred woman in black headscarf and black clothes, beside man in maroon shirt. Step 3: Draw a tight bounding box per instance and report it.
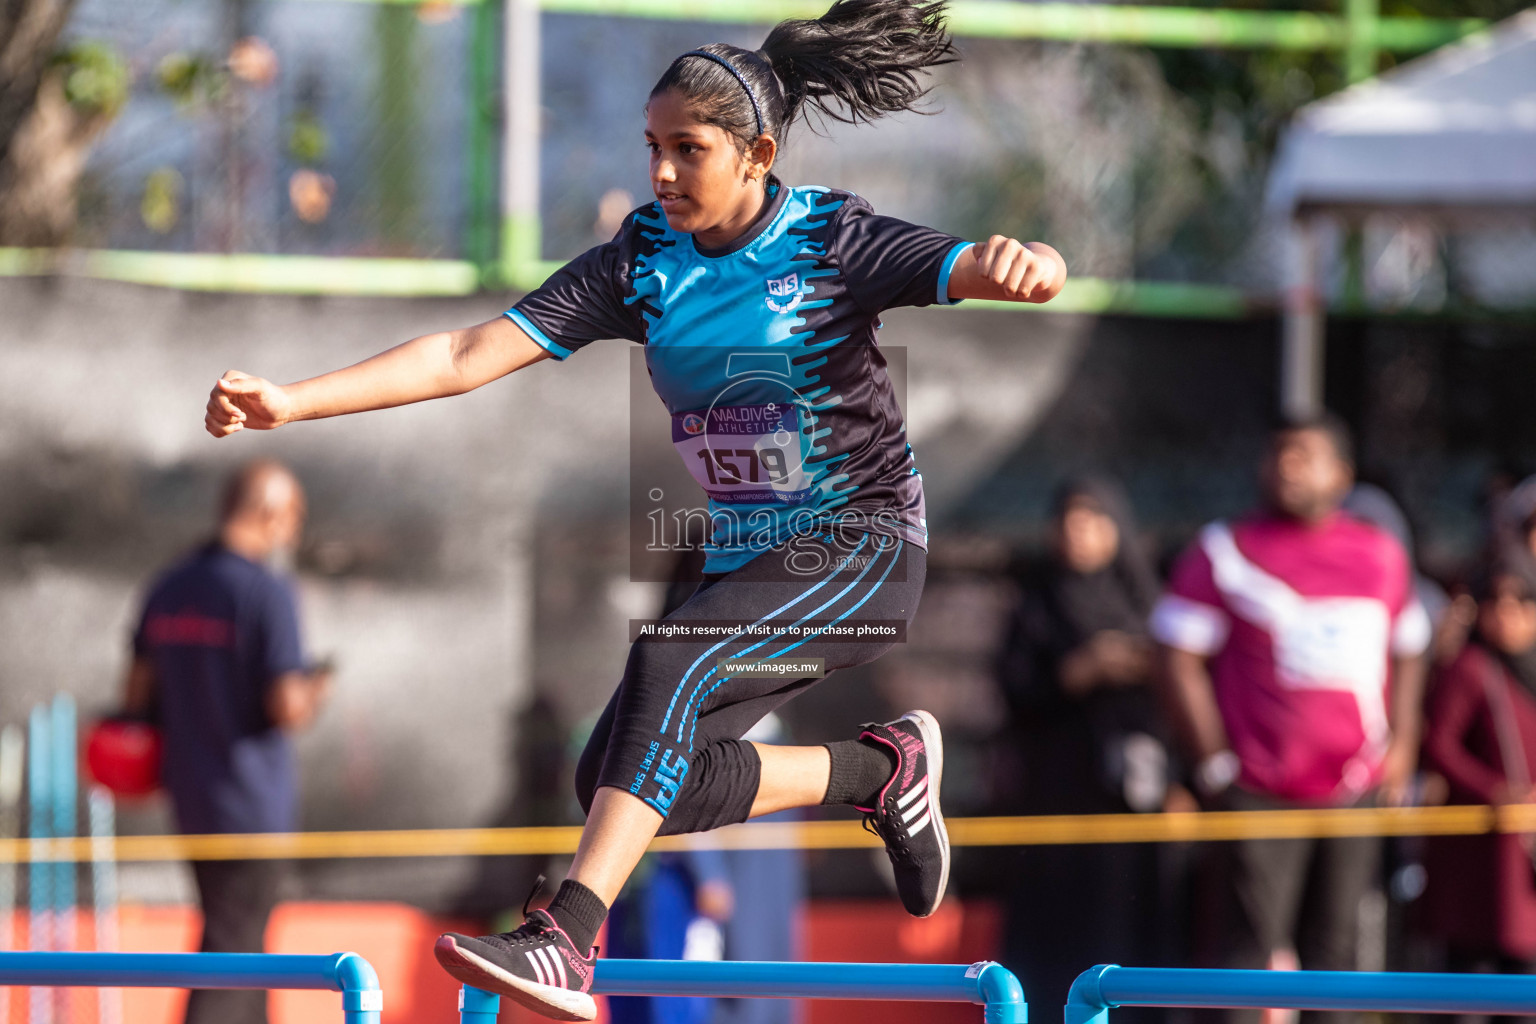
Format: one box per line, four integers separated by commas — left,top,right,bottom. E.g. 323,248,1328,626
998,477,1181,1019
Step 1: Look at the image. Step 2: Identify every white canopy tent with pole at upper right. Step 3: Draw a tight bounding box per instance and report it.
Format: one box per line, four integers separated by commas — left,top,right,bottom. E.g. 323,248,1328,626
1267,8,1536,413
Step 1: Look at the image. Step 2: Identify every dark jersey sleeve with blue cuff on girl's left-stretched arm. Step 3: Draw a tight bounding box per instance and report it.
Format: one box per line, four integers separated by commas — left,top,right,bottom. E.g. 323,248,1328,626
505,216,645,359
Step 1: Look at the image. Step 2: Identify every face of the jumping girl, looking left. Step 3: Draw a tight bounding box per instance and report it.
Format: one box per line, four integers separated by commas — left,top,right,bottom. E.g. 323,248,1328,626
645,89,773,249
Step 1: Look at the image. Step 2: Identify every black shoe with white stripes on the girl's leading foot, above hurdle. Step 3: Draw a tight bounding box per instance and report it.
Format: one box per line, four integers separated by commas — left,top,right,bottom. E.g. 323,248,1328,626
432,910,598,1021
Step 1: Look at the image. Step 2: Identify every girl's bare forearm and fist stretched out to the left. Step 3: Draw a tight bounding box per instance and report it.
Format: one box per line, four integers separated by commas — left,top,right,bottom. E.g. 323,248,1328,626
203,316,550,438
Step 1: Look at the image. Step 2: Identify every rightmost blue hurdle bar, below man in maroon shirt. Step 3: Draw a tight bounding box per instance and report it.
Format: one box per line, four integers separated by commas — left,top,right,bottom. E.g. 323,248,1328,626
1066,964,1536,1024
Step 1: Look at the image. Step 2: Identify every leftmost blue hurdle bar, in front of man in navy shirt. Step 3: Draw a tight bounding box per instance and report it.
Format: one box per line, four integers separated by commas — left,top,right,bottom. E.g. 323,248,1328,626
0,952,384,1024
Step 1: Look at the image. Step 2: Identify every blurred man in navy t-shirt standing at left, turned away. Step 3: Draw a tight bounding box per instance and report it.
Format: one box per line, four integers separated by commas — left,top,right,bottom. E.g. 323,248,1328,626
126,461,329,1024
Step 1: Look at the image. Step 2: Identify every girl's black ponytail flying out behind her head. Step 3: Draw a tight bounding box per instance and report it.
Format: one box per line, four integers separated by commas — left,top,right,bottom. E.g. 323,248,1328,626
759,0,955,126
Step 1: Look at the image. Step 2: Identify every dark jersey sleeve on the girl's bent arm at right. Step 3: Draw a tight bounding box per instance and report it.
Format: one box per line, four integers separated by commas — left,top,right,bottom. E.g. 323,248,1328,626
833,197,971,315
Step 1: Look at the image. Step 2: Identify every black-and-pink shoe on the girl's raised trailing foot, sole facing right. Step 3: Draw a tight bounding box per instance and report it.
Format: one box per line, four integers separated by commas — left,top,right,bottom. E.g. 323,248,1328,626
859,711,949,918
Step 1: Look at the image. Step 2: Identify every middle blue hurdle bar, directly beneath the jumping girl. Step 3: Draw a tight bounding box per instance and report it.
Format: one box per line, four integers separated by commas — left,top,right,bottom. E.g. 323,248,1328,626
459,960,1029,1024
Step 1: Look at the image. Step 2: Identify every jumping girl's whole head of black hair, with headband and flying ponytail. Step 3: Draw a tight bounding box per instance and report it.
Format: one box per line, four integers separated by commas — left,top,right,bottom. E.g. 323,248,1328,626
651,0,955,150
